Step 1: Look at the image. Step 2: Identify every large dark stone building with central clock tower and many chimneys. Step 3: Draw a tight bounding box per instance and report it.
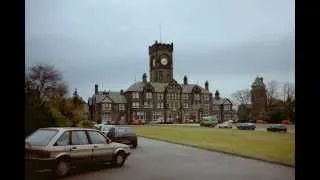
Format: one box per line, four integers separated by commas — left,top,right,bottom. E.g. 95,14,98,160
88,41,233,123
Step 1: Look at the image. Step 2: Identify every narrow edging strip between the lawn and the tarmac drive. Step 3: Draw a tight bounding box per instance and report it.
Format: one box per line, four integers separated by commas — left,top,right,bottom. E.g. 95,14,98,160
138,135,295,168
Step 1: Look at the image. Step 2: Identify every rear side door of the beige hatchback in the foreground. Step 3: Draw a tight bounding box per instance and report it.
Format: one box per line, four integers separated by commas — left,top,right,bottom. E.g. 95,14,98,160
70,130,92,164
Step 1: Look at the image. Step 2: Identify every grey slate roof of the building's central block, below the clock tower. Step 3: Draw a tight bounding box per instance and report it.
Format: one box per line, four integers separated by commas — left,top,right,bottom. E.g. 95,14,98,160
126,81,210,94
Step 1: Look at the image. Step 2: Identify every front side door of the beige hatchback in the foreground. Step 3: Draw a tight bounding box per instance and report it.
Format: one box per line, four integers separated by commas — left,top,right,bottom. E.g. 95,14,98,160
88,130,113,162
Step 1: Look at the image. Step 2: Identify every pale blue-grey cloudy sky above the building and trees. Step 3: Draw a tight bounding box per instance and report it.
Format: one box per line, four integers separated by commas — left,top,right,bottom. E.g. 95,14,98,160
25,0,295,99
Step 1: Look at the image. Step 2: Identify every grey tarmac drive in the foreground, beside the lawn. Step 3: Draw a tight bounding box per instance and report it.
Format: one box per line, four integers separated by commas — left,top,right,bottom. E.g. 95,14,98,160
33,138,295,180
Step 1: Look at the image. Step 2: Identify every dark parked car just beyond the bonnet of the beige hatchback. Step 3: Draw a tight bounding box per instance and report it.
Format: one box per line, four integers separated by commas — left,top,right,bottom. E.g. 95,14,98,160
107,126,138,148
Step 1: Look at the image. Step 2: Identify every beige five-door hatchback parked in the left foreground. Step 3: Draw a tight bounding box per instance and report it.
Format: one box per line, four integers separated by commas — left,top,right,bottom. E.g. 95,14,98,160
25,128,130,177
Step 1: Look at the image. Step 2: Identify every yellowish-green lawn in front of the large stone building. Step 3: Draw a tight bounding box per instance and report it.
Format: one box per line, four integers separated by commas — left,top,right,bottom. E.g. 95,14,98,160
134,126,295,165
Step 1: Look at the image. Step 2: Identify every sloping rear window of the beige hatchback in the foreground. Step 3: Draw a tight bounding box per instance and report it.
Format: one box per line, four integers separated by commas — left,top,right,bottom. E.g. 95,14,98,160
26,129,58,146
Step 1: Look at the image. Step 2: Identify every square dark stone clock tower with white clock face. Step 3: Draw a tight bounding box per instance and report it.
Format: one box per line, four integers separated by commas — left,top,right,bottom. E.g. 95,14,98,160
149,41,173,83
